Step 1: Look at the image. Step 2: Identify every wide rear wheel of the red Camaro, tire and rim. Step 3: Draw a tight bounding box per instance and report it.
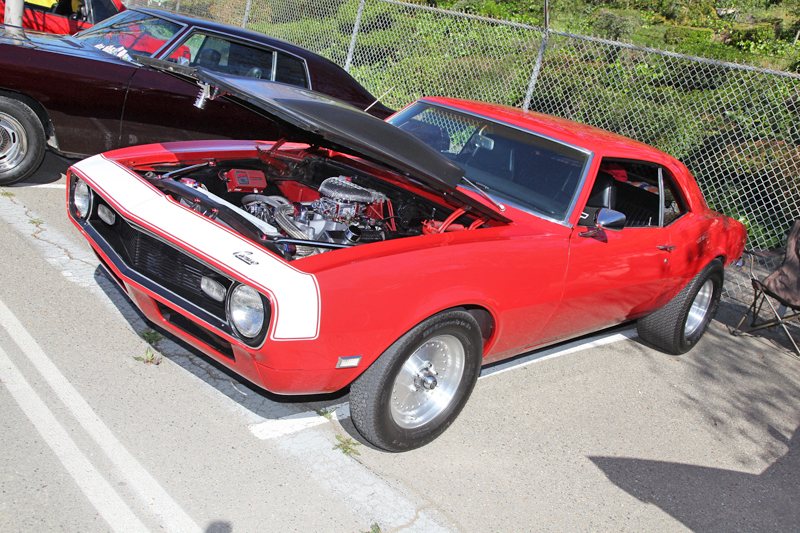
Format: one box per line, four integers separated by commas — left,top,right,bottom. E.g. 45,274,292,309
637,259,725,355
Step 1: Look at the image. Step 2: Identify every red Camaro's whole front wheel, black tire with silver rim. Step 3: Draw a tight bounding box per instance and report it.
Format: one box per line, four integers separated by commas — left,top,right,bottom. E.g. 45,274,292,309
350,309,483,452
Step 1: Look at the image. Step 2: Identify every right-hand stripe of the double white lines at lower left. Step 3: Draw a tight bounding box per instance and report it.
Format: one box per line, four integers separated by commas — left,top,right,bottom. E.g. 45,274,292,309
0,301,200,533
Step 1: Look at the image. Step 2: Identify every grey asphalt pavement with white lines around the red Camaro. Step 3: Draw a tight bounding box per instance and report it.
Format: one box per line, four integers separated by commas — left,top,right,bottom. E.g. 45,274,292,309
0,154,800,533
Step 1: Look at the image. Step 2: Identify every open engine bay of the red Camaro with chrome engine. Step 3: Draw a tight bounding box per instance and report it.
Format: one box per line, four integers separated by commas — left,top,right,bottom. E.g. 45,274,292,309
140,151,487,261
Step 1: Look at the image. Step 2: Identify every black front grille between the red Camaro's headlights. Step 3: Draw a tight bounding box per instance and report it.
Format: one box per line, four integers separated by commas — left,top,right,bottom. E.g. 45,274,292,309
92,215,231,320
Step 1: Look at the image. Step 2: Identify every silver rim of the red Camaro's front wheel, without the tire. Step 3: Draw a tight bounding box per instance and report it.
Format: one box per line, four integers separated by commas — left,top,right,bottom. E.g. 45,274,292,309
390,335,465,429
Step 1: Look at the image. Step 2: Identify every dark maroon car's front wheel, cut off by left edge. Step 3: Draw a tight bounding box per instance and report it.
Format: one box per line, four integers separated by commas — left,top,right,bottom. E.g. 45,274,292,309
0,96,46,185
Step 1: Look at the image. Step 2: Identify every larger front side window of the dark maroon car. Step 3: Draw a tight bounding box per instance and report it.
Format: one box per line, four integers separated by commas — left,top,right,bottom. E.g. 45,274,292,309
169,33,274,80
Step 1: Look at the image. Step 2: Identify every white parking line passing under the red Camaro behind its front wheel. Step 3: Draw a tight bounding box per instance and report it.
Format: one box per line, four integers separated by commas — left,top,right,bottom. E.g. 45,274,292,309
250,328,636,440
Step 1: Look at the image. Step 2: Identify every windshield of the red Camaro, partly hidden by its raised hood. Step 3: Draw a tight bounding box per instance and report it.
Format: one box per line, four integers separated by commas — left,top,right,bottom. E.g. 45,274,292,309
389,102,591,220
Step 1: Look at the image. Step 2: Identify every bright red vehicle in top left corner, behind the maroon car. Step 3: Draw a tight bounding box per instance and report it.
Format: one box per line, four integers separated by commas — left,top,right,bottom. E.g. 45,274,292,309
0,0,125,35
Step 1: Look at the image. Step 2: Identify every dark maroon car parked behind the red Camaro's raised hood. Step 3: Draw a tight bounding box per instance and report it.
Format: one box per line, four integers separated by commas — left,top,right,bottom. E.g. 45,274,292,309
0,8,392,185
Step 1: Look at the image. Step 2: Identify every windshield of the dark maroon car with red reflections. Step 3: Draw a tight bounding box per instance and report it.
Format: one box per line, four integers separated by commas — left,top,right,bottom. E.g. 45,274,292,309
75,11,183,60
